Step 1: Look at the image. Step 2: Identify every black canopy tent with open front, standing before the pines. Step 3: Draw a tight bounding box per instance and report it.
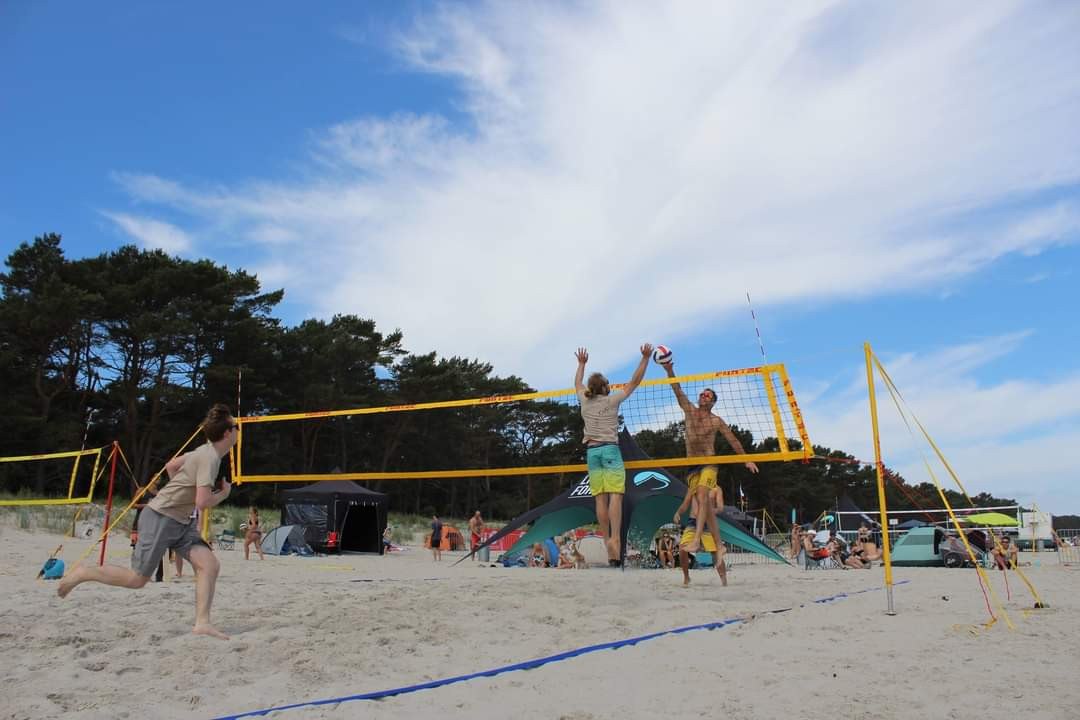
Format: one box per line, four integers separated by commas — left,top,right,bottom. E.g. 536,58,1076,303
281,480,387,555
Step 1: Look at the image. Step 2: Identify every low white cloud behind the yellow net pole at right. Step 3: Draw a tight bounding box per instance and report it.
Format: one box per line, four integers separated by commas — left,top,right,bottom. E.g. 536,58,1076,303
801,334,1080,514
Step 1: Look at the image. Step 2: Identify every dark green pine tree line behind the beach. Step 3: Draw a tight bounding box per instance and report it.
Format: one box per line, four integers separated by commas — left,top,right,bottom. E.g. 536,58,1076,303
0,234,1012,521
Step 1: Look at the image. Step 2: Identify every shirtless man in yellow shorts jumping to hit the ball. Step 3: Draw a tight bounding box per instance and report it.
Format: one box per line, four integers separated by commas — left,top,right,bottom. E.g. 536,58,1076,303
663,363,757,563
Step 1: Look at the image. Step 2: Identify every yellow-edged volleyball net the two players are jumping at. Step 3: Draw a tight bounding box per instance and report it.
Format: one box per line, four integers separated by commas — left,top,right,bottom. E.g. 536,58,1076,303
233,364,812,484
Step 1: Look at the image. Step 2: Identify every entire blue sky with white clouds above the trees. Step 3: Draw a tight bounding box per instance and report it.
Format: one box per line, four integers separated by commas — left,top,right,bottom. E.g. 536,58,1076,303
6,2,1080,513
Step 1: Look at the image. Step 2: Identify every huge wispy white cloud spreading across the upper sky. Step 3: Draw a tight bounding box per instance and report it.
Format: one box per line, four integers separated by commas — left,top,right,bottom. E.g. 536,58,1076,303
107,1,1080,386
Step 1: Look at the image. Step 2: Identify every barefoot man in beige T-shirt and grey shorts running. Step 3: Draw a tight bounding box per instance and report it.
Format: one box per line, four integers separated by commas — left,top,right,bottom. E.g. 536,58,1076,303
56,404,240,640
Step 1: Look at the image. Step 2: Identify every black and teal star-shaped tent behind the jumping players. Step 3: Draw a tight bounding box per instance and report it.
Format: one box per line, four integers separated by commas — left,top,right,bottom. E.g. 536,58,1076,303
459,429,787,563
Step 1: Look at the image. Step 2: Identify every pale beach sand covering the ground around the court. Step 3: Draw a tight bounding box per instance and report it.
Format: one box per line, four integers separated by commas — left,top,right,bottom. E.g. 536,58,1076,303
0,527,1080,720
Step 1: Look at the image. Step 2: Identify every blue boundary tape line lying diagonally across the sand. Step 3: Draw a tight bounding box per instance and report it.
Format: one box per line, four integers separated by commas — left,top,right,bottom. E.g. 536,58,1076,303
214,580,910,720
